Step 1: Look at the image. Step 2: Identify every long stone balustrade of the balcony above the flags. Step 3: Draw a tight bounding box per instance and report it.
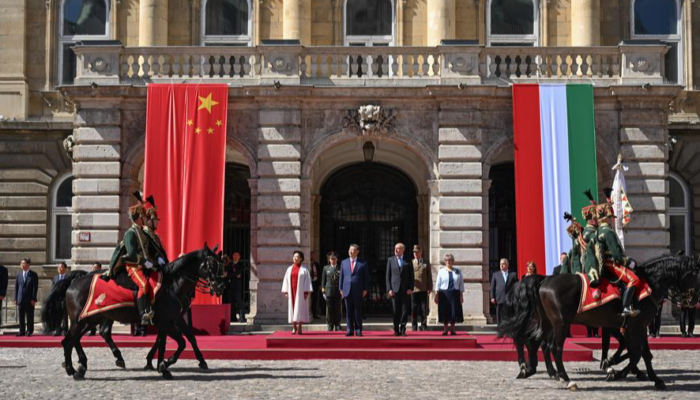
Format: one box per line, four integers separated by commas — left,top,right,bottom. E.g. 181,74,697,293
74,43,668,86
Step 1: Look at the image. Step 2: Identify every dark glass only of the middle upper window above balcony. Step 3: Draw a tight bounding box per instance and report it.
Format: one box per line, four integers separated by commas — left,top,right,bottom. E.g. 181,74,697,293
346,0,393,36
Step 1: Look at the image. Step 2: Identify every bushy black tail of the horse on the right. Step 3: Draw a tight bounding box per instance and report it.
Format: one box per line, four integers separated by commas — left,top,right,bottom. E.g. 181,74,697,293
498,275,545,344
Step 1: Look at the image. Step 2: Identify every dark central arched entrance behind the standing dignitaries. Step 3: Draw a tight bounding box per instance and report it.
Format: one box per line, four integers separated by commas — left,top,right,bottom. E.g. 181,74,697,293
321,163,418,315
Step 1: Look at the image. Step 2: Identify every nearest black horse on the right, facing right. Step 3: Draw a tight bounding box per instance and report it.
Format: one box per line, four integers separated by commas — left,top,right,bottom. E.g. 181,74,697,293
499,255,700,390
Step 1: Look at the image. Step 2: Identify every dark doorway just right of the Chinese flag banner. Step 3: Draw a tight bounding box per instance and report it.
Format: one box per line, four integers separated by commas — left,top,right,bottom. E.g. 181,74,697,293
223,162,250,318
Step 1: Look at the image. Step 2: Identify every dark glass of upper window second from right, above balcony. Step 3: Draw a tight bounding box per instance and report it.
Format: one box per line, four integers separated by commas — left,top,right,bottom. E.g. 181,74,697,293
491,0,535,35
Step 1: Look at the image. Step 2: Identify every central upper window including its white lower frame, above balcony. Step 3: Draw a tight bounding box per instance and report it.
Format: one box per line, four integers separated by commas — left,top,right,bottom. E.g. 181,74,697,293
345,0,396,46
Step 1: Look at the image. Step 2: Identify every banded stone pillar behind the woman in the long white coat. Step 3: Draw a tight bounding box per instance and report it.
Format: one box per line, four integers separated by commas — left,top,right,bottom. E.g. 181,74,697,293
255,109,308,324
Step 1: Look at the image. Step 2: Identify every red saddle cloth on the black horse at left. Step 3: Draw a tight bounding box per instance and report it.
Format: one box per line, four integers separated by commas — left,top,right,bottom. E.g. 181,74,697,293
79,273,163,319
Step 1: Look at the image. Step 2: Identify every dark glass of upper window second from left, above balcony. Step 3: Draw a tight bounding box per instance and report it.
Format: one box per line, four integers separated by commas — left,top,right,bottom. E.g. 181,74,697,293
204,0,248,36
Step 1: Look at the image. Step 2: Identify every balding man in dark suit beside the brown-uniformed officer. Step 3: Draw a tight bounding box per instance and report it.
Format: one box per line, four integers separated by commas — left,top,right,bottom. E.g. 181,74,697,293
386,243,414,336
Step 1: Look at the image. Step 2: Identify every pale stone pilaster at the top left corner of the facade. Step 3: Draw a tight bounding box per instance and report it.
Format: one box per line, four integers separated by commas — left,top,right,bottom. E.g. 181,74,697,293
0,0,29,120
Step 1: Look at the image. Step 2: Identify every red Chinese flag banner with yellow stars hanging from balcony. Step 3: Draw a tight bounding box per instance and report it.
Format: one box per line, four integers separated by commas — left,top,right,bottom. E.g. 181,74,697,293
143,84,228,304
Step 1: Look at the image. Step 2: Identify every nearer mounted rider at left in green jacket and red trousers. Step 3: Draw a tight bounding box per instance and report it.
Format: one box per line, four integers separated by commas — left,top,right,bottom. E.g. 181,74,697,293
110,192,158,325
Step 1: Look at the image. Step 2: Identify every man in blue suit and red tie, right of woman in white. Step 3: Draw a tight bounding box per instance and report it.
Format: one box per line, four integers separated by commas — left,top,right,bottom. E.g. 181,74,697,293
339,244,369,336
